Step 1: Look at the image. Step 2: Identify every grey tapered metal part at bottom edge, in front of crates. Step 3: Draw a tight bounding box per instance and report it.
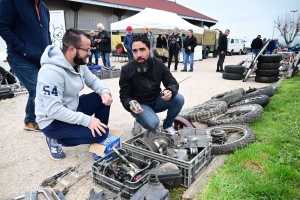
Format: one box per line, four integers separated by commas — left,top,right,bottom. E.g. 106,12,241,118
130,174,171,200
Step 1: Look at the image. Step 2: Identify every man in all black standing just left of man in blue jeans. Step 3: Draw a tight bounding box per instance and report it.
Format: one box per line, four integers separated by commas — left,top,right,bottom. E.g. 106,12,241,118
168,28,182,72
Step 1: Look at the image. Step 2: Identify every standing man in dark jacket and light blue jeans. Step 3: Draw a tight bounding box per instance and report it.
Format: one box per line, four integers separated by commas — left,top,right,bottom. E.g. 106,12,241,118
181,29,197,72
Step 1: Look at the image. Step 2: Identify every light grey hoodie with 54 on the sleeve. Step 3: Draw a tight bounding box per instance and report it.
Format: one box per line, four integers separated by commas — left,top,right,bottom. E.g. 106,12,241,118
35,45,110,129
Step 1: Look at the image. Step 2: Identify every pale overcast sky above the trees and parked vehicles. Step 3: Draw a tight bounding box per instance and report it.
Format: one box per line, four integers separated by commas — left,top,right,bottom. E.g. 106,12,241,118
176,0,300,43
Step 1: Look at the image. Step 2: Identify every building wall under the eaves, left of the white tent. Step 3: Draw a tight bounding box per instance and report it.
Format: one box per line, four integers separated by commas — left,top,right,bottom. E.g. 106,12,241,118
43,0,138,31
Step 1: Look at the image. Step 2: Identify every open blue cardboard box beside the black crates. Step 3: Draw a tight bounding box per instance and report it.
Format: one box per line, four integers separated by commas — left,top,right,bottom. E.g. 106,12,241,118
89,130,122,157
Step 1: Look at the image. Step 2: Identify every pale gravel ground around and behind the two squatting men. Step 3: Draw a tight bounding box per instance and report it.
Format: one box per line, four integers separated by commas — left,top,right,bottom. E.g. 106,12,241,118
0,55,268,200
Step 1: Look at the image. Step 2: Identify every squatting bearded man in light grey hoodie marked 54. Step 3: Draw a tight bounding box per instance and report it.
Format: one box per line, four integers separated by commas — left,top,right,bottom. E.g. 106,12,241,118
35,29,113,160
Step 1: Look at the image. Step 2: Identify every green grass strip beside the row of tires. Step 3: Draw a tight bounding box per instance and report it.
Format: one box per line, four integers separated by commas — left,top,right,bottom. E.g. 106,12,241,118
171,75,300,200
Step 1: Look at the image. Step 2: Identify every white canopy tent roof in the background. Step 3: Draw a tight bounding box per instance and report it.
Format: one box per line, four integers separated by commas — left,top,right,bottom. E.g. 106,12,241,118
110,8,204,34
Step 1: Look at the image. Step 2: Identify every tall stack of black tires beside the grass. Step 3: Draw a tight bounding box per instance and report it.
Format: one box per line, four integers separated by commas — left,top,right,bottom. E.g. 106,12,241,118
255,54,282,83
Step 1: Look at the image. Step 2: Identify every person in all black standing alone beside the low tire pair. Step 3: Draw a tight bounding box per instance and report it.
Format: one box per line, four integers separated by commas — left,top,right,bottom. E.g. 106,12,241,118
216,29,230,72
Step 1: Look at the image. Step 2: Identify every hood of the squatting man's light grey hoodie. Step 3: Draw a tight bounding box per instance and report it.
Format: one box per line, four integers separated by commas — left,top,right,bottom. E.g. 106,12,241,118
41,45,77,73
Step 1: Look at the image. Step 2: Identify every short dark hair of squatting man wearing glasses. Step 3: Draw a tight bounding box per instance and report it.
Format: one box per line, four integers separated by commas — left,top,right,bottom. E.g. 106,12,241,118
62,28,90,53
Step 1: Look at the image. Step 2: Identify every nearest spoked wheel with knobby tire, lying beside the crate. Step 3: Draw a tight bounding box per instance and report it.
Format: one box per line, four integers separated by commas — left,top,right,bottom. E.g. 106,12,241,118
208,124,254,155
